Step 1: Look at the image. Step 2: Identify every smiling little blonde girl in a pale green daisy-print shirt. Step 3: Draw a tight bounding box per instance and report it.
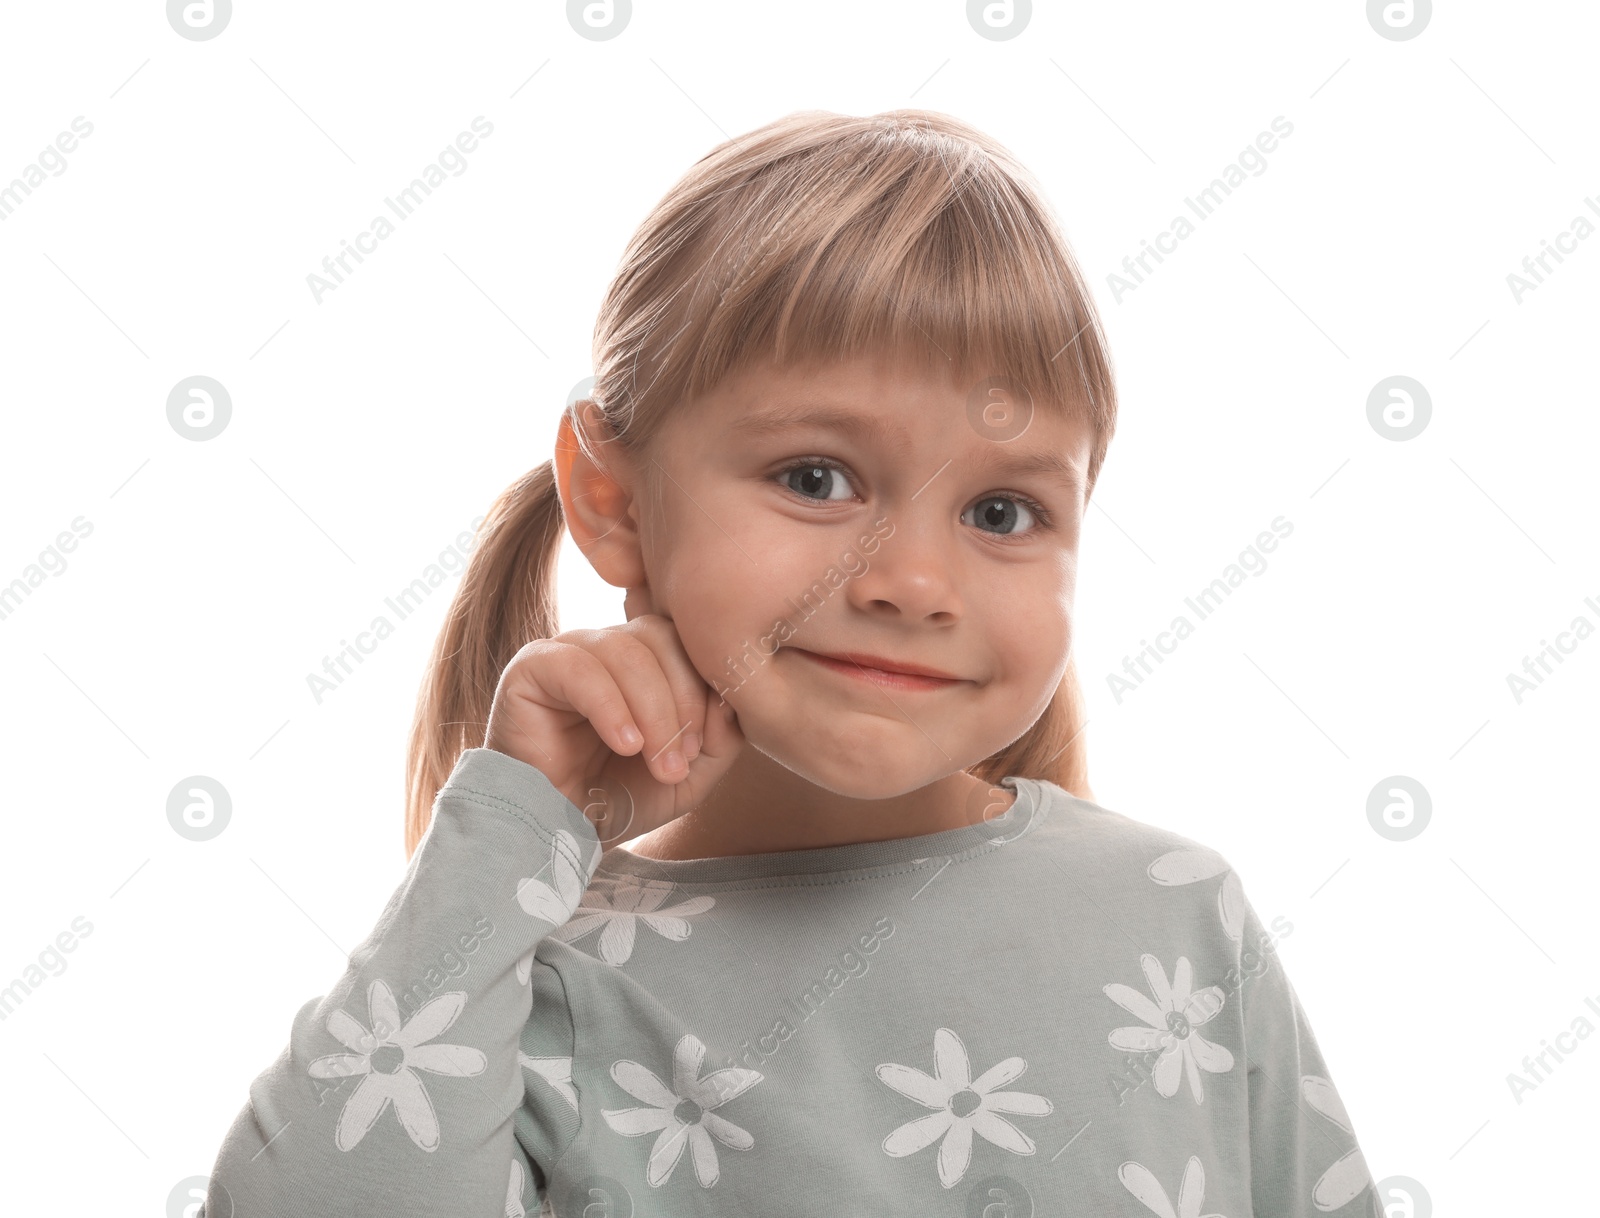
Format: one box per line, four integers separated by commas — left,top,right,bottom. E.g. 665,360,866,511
203,110,1379,1218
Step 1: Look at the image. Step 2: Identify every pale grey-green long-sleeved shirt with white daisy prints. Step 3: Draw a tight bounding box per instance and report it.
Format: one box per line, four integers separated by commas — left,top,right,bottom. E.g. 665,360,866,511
202,749,1381,1218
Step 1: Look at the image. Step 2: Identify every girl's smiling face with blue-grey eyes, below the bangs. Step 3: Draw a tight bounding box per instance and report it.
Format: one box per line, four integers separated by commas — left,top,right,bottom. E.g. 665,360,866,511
629,348,1091,799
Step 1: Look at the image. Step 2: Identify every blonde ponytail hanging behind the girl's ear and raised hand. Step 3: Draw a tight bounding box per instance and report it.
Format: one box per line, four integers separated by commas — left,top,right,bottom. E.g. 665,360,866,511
405,461,565,859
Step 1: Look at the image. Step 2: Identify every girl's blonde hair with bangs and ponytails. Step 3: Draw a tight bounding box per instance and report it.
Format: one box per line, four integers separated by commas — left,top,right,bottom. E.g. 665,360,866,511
405,110,1117,858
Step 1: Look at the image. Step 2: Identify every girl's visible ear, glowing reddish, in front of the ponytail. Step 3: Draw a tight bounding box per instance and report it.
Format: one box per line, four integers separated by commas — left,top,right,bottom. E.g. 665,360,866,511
555,402,645,589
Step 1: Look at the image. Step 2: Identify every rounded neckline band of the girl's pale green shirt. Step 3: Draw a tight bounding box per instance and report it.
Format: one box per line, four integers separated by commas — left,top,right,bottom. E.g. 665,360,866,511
595,775,1046,883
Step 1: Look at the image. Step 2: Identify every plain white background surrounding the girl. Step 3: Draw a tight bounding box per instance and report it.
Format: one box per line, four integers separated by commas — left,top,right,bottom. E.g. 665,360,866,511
0,0,1600,1218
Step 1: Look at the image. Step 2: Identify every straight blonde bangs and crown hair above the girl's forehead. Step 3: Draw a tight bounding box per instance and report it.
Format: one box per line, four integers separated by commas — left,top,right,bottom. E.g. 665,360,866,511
597,112,1115,487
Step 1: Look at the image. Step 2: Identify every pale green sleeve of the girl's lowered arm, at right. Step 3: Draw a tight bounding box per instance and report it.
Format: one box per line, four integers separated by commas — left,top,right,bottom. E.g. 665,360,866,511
1240,903,1382,1218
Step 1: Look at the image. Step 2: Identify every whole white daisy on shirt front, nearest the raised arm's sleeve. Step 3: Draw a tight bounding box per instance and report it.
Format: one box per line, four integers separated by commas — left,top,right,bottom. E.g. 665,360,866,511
600,1034,765,1188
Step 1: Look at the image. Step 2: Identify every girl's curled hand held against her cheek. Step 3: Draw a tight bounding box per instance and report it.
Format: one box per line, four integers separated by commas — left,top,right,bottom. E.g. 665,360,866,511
483,615,744,845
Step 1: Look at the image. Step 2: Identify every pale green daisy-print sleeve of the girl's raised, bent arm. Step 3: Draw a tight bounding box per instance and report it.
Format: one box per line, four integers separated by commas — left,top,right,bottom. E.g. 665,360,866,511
200,749,600,1218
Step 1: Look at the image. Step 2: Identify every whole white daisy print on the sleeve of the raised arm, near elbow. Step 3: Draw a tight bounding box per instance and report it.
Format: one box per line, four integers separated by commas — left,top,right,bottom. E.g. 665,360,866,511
307,980,488,1151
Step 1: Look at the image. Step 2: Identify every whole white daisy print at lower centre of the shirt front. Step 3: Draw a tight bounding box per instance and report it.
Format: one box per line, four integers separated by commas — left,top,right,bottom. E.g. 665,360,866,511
875,1028,1054,1188
